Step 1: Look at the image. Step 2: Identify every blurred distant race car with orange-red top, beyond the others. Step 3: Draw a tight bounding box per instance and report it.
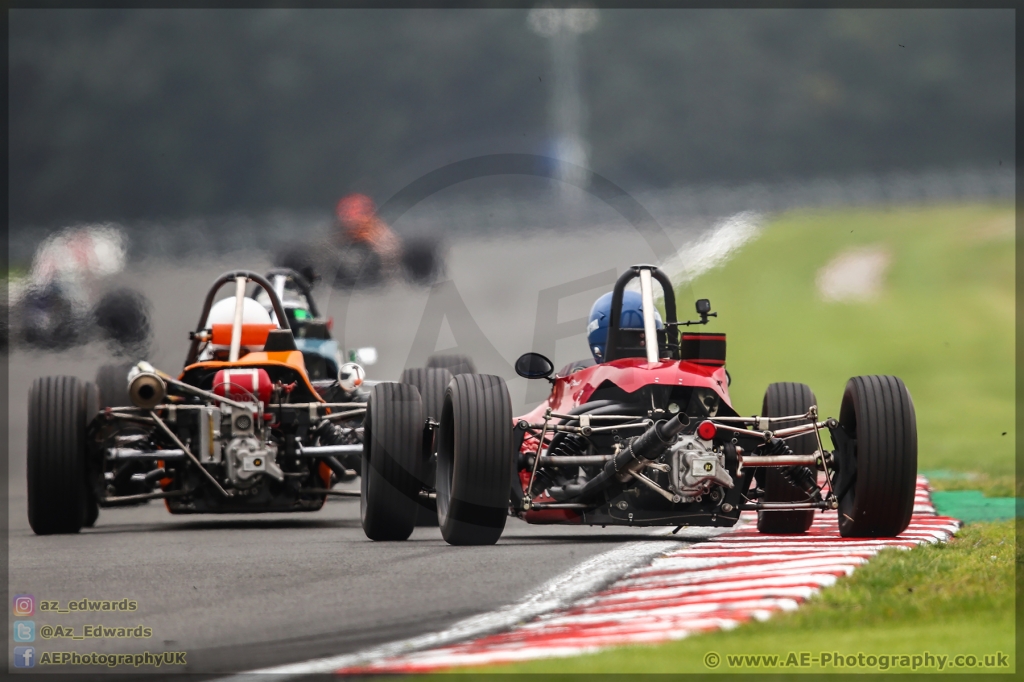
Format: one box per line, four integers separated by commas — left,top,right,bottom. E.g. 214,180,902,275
274,195,443,289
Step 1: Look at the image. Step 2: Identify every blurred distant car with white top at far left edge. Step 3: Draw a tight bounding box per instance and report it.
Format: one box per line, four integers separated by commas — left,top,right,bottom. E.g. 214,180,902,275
4,224,150,352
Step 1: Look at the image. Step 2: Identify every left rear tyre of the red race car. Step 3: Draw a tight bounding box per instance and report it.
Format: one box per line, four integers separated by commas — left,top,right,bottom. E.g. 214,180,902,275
436,374,513,545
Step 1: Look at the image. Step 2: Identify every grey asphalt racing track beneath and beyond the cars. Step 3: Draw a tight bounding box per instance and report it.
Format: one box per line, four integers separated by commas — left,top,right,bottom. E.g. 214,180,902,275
8,215,716,673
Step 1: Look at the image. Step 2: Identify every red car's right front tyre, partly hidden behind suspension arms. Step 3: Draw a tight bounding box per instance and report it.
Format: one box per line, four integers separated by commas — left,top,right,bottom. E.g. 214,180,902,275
758,382,818,535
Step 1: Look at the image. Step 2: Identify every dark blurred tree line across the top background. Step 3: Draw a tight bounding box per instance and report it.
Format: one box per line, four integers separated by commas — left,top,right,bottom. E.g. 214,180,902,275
8,9,1015,227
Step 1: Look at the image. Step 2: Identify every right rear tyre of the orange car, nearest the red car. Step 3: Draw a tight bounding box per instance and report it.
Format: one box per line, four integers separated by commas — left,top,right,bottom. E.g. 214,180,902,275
359,383,425,540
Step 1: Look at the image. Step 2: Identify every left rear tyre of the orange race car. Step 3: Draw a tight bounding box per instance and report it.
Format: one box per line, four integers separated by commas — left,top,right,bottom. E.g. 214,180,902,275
27,377,89,536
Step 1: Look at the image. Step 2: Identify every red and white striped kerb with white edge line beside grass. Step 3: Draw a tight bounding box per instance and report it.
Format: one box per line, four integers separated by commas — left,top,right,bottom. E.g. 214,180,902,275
228,477,962,680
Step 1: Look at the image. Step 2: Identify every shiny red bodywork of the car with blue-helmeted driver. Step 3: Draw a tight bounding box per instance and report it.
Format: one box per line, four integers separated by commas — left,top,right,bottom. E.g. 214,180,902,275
514,357,732,523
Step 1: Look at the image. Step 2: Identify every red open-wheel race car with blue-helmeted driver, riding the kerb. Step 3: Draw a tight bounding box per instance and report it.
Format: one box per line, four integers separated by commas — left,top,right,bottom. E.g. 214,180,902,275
362,265,916,545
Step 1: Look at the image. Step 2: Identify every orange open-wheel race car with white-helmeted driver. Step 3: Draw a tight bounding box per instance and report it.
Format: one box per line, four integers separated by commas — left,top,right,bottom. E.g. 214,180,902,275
27,270,376,535
